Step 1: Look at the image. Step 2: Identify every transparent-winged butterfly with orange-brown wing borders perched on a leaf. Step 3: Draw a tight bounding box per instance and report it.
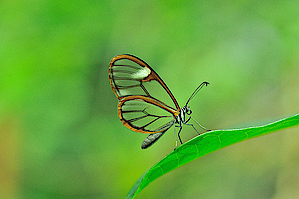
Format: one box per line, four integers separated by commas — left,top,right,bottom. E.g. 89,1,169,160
109,54,209,149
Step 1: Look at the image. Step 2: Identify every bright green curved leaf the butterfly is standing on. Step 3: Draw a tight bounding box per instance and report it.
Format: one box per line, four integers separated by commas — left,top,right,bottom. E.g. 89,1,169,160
126,114,299,198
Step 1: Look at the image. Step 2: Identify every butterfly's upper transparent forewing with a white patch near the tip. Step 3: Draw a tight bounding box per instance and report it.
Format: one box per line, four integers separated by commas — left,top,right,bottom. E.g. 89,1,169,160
109,55,180,110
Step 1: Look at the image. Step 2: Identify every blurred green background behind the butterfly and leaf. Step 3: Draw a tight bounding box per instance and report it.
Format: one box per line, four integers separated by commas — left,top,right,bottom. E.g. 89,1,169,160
0,0,299,199
